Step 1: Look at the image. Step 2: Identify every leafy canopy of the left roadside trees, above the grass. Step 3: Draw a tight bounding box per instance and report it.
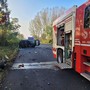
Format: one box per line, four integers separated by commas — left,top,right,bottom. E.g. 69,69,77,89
0,0,24,46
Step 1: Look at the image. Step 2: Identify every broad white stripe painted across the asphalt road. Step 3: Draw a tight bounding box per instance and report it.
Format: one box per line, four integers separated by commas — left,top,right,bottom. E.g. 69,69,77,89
11,61,57,70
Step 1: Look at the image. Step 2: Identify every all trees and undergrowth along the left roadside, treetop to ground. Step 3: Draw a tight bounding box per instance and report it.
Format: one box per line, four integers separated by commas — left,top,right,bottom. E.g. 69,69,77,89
0,0,24,62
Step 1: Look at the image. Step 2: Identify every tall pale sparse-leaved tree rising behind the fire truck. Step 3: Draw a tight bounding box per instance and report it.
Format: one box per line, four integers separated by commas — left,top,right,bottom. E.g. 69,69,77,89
29,7,66,44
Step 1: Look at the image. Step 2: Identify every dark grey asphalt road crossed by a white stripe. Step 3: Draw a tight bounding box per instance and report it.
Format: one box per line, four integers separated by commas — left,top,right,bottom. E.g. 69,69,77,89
0,45,90,90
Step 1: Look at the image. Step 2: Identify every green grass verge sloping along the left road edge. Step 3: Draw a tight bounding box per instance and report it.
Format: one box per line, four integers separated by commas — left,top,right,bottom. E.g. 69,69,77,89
0,45,19,83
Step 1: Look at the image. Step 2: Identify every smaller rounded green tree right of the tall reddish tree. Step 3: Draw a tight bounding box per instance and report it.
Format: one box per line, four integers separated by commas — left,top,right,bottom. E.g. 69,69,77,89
6,18,23,44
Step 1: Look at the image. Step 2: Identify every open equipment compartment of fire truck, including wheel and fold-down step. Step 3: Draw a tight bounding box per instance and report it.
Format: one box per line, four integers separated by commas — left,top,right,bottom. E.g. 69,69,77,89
57,25,72,69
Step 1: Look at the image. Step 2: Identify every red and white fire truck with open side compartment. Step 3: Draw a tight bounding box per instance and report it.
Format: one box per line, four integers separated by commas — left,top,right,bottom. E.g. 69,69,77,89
53,0,90,81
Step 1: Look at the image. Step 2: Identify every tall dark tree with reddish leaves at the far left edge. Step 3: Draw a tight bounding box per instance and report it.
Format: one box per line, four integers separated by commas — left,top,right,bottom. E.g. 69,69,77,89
0,0,9,45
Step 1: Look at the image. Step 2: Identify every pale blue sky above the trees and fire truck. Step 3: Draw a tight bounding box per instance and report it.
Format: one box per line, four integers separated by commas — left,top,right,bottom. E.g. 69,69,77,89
8,0,88,38
